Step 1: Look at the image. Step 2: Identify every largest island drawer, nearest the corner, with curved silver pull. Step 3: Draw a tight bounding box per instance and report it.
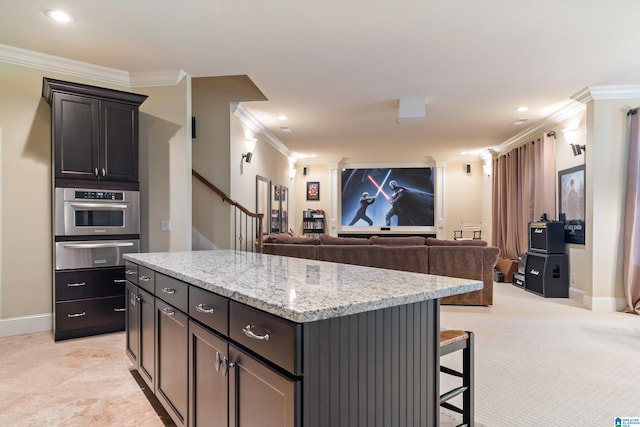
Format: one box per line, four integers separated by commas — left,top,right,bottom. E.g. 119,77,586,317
229,301,302,375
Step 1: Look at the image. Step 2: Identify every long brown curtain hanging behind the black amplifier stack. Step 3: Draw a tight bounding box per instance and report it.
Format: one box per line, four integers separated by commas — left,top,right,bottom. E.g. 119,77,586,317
491,134,556,259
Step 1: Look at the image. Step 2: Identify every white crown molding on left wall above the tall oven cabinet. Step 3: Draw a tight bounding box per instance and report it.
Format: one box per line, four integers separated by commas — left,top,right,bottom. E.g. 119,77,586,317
0,44,131,86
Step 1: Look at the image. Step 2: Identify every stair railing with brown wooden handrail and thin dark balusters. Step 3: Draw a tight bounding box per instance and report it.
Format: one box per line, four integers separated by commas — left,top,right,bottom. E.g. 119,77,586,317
191,169,264,253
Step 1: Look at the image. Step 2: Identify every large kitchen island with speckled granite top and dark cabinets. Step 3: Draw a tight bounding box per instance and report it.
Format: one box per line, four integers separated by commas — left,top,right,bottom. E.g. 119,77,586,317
125,250,482,427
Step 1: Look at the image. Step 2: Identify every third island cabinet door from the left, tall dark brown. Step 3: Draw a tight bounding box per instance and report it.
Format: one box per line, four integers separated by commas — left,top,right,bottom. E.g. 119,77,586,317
156,298,189,426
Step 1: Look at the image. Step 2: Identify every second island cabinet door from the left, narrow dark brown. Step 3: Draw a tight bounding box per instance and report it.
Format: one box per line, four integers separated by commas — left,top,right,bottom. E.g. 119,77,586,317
138,288,156,392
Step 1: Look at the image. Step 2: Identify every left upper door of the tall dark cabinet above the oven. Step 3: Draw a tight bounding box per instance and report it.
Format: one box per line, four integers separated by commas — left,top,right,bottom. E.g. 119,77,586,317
52,93,100,180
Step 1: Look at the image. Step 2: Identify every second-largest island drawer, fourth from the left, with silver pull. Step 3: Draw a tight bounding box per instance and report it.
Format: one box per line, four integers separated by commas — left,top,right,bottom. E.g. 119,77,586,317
189,286,229,336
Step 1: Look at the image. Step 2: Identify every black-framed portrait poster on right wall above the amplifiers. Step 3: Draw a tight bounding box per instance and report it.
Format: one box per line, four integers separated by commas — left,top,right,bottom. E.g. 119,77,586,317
558,165,585,245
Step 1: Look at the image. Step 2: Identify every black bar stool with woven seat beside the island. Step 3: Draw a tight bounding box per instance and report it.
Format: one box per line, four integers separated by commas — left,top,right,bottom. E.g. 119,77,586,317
440,330,474,427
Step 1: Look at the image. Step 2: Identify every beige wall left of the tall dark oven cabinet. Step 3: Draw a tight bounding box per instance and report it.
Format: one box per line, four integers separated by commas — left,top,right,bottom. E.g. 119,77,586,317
0,63,129,326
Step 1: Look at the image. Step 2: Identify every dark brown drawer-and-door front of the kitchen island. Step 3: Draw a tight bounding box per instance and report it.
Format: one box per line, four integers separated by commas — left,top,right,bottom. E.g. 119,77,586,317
126,262,302,427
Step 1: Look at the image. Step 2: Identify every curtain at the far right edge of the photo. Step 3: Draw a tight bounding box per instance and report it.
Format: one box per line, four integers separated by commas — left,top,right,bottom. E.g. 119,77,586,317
623,110,640,314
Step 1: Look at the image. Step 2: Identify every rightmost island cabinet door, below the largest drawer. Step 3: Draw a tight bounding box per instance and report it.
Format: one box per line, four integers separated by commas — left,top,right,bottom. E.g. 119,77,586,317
229,344,301,427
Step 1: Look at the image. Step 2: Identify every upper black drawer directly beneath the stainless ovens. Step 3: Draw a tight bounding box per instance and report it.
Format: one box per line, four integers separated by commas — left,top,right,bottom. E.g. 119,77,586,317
55,267,126,302
